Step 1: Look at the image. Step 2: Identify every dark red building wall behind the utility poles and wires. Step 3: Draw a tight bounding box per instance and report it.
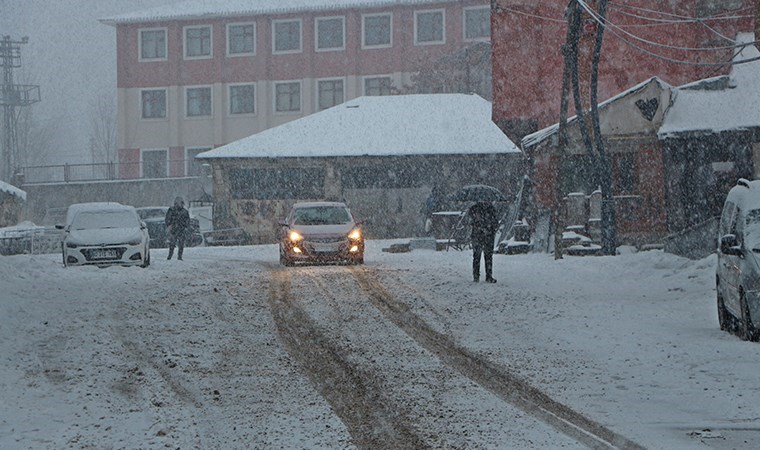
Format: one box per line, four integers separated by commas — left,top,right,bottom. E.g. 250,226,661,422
491,0,755,142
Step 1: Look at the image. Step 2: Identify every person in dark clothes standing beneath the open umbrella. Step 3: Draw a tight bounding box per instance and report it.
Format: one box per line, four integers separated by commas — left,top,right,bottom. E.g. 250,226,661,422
467,202,499,283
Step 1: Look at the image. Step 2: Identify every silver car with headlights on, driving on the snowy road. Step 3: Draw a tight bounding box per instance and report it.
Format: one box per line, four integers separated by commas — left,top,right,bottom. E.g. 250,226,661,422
279,202,364,266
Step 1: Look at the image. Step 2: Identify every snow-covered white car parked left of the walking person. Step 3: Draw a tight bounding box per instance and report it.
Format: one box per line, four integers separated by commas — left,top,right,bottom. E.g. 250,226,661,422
56,202,150,267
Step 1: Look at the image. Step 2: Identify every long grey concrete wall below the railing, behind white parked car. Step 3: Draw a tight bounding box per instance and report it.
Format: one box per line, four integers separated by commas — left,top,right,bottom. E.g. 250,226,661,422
21,177,211,225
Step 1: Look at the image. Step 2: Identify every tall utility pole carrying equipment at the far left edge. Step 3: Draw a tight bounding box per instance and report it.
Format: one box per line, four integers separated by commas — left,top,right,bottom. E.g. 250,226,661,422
0,36,40,181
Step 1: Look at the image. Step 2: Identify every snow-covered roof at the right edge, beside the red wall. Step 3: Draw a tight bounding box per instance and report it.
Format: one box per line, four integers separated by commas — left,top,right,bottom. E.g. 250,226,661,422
658,33,760,139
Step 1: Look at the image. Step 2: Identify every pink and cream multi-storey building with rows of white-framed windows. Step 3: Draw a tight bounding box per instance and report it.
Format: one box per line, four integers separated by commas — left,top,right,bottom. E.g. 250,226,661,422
101,0,490,178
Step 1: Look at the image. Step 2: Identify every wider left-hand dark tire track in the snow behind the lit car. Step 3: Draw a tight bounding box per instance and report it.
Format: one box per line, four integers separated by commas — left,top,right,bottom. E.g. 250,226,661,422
269,269,429,449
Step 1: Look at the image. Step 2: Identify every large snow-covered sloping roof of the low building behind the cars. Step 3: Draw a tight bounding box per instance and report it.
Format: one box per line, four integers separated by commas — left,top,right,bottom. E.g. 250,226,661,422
196,94,520,159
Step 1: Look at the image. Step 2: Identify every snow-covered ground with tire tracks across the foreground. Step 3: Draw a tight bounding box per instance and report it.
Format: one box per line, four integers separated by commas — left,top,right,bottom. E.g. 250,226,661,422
0,241,760,449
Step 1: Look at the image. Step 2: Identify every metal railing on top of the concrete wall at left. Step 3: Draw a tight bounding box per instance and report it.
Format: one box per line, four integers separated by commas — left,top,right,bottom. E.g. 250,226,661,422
20,159,201,184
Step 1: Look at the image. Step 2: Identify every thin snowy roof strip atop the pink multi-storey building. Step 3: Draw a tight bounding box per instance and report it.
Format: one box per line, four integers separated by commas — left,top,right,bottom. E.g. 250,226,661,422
100,0,458,25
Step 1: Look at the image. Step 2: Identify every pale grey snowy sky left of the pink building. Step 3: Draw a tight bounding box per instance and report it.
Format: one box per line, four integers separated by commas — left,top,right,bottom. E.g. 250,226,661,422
0,0,178,164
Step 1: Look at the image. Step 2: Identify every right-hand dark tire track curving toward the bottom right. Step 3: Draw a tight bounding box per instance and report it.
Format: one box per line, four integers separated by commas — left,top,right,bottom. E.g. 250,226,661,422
350,267,644,450
